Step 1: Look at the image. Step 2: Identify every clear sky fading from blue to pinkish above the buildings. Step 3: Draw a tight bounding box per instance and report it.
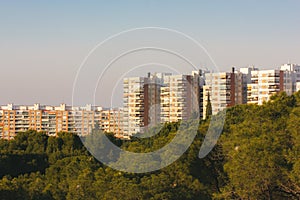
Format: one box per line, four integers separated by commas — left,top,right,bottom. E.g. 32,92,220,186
0,0,300,106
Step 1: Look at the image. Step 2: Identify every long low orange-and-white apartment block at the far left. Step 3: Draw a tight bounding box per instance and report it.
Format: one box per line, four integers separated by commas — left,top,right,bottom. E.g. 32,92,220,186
0,104,122,139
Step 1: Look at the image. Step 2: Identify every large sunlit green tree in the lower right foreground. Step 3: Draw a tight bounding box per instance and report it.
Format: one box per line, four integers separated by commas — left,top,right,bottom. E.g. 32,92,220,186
216,93,299,199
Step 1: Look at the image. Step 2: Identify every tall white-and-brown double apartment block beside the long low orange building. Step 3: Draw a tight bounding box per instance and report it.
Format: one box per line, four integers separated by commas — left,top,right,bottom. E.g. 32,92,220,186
123,72,203,136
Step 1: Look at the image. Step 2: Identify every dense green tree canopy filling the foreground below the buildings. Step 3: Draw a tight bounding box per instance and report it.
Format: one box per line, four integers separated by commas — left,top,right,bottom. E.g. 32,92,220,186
0,92,300,200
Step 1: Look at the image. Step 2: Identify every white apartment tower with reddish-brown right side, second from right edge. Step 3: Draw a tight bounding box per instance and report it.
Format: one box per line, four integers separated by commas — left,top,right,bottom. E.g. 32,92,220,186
247,70,284,105
